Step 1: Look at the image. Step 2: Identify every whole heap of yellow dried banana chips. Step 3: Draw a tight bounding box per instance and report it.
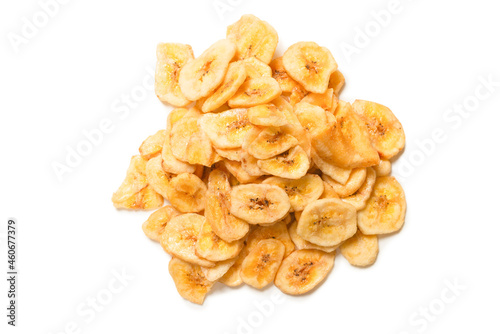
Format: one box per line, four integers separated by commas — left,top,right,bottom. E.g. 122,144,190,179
112,15,406,304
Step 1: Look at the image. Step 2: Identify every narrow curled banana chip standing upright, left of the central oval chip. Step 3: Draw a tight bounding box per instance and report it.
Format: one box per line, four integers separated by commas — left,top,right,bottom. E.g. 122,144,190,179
205,169,250,242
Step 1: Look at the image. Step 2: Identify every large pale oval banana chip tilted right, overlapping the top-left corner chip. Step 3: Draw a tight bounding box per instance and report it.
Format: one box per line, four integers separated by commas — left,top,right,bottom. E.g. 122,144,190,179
179,39,236,101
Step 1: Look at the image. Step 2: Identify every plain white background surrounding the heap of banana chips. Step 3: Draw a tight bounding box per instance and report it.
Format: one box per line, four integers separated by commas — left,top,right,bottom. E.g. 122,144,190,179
0,0,500,334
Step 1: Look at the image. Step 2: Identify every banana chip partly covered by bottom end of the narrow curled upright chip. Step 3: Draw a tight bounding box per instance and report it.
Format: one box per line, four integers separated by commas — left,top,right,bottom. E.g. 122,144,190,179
195,221,243,262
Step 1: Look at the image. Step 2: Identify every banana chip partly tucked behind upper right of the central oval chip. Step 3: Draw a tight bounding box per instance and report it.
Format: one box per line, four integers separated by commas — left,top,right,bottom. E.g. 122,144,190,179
262,174,324,211
